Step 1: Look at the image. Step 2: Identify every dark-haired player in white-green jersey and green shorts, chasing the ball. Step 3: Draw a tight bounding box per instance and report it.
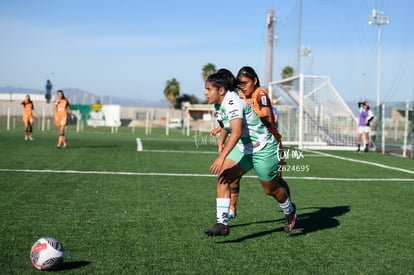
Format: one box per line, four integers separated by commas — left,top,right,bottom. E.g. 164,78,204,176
204,73,296,236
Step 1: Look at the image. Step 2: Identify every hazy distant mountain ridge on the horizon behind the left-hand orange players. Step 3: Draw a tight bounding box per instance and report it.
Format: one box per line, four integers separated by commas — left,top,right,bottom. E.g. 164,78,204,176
0,86,169,108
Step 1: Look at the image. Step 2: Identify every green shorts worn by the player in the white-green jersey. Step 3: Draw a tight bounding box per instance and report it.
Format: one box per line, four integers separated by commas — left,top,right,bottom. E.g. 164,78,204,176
227,142,282,181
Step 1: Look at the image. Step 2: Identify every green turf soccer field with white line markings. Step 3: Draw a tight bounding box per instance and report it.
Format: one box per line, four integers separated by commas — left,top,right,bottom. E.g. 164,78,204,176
0,128,414,274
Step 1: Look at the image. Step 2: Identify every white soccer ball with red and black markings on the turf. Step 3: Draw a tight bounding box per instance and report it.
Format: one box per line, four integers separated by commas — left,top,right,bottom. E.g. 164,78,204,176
30,237,65,270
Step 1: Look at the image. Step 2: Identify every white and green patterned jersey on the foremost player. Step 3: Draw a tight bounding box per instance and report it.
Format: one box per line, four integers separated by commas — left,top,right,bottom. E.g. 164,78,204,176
214,91,275,154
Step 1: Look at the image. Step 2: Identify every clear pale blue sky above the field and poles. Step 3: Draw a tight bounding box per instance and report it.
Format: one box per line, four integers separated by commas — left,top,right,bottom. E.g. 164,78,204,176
0,0,414,104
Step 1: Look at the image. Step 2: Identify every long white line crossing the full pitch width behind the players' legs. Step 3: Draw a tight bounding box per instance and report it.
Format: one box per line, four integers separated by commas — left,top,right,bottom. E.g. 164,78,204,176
0,168,414,182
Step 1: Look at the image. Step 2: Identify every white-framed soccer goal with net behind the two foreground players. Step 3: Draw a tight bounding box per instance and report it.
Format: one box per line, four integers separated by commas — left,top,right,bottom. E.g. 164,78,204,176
269,74,358,150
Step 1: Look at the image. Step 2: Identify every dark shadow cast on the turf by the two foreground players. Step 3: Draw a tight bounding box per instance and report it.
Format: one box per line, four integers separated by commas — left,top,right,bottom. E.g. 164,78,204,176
218,206,350,243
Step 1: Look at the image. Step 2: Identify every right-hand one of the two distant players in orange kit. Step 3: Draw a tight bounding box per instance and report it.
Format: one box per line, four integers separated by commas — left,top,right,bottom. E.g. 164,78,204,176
54,90,74,149
